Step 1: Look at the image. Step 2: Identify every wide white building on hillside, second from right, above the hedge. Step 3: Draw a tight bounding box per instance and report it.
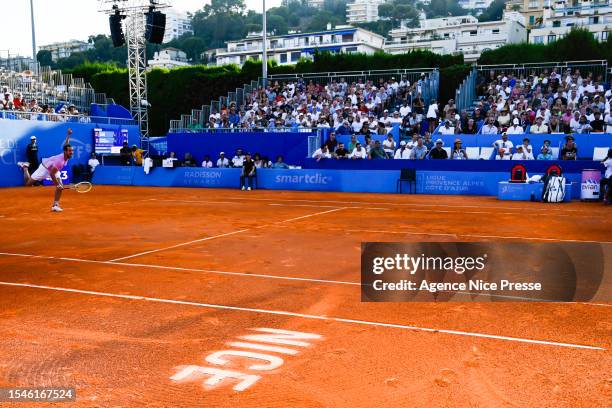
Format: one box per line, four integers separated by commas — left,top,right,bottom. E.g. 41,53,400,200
385,16,527,62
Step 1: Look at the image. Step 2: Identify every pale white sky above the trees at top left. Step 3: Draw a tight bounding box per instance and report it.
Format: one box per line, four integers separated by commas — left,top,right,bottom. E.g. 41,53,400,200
0,0,281,58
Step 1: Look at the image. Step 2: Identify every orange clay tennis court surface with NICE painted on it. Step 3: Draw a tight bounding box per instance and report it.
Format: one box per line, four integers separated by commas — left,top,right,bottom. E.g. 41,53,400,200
0,186,612,408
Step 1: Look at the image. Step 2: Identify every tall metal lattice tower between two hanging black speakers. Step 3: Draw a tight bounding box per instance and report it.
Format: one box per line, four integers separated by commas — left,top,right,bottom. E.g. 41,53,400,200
98,0,170,143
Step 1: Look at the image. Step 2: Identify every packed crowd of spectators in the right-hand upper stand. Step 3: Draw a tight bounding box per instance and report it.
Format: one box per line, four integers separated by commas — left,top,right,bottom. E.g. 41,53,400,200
468,69,612,134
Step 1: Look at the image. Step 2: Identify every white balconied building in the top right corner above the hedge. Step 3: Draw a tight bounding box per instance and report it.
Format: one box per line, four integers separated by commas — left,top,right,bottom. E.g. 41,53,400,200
529,0,612,44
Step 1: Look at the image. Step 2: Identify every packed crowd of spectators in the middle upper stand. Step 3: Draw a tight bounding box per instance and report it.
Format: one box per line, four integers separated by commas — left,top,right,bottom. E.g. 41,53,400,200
200,73,427,135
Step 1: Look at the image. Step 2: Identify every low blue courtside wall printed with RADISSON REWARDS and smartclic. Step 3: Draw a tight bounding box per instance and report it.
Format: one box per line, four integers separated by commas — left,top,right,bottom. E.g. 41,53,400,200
93,161,599,197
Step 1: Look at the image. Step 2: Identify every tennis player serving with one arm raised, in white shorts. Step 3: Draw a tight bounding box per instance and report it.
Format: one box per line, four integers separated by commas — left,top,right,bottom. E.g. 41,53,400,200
17,129,74,212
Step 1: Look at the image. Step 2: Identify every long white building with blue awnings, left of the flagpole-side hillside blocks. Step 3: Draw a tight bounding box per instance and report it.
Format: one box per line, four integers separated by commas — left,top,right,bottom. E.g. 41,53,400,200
216,26,385,69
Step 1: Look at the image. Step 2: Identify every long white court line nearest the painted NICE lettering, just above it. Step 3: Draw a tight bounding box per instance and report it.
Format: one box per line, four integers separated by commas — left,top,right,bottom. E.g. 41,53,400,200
0,282,606,351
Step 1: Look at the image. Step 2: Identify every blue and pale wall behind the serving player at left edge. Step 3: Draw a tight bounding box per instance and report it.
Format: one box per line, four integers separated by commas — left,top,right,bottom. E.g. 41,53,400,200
0,120,140,187
